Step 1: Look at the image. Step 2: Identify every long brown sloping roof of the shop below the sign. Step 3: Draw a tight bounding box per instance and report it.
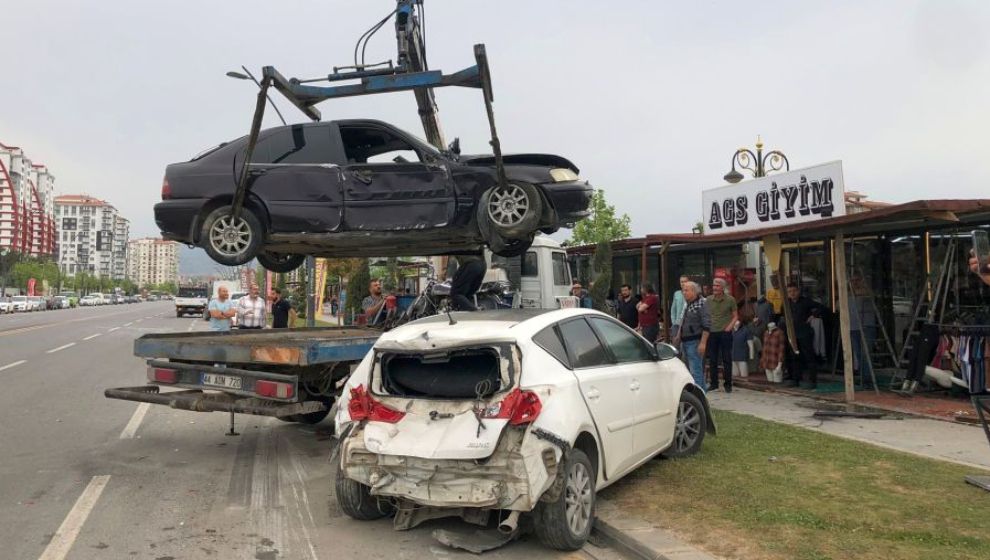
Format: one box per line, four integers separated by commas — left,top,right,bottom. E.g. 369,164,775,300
568,199,990,254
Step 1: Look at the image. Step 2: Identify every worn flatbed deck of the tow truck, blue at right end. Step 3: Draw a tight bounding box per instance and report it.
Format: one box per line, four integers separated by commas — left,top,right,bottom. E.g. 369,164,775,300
134,327,381,366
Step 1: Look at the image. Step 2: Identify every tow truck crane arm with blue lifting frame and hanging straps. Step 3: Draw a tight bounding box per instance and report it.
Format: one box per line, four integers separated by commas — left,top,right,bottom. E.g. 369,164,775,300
232,0,506,221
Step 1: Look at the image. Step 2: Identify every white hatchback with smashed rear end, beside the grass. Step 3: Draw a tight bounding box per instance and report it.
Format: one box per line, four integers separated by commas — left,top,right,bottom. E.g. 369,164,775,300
336,309,715,550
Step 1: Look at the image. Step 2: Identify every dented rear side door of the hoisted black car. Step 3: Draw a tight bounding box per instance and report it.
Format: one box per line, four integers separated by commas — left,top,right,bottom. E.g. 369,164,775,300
234,123,344,232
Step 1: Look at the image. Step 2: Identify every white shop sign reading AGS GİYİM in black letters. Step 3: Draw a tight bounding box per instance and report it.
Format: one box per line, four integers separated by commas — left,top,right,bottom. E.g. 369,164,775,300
702,161,846,233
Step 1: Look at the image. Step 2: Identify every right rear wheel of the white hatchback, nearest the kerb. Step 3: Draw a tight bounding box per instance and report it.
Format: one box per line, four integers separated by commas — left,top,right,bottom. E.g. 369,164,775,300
533,449,596,550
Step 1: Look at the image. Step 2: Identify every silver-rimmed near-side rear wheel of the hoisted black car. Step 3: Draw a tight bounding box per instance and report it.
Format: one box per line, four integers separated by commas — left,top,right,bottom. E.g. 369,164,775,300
200,205,265,266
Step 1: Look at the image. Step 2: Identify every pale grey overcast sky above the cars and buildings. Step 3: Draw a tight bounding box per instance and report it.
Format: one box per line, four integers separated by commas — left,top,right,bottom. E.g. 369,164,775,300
0,0,990,248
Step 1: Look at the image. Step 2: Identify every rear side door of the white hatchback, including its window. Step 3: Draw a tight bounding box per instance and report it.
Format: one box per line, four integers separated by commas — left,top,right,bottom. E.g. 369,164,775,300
558,318,635,476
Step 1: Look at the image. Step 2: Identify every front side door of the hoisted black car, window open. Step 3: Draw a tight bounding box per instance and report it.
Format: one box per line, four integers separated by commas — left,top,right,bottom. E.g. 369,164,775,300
339,123,455,231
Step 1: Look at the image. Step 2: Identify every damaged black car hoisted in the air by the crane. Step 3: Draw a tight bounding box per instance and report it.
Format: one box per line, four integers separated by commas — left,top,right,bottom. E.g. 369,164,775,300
155,120,593,272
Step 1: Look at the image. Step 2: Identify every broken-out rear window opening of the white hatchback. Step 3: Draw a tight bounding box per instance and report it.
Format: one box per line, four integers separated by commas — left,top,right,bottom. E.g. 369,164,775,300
378,347,515,399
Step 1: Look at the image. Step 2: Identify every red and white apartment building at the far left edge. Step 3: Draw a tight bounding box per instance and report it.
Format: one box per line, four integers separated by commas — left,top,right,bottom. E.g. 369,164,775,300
0,143,57,257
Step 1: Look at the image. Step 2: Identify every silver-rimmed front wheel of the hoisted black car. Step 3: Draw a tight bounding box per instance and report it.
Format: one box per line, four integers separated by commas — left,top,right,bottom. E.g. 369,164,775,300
478,181,543,240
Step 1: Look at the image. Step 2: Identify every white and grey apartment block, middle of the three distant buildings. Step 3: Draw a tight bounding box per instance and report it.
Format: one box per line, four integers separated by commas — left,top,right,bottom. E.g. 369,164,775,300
55,194,129,280
